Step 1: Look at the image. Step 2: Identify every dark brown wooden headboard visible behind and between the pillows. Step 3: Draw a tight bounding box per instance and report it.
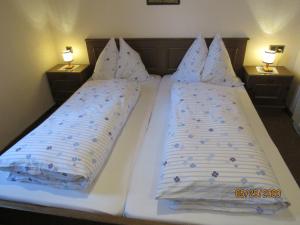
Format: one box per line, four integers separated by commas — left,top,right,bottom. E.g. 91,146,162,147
85,38,249,76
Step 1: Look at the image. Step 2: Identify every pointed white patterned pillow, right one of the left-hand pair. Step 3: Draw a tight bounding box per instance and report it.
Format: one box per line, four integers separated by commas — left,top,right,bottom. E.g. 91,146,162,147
116,38,149,81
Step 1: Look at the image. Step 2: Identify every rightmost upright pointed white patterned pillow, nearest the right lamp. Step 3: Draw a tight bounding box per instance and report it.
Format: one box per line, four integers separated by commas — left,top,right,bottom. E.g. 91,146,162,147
201,35,243,87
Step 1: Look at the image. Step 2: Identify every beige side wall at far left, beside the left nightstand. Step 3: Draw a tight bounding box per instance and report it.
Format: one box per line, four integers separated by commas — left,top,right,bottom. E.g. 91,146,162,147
0,0,57,149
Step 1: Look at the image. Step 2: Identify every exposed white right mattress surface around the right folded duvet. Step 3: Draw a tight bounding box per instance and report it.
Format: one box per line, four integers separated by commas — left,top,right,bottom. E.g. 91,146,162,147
124,76,300,225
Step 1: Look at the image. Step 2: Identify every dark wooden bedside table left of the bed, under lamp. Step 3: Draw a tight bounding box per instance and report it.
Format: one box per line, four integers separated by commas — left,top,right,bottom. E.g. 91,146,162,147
46,64,90,104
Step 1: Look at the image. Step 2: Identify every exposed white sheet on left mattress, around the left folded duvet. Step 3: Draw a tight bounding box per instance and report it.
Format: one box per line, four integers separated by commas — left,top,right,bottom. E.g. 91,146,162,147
0,76,160,215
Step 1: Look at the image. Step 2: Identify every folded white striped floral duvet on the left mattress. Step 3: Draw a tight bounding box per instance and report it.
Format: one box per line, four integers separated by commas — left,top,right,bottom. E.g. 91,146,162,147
0,80,140,189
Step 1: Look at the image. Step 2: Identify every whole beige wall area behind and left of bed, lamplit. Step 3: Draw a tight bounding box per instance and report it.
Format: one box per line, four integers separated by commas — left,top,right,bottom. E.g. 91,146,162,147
0,0,300,147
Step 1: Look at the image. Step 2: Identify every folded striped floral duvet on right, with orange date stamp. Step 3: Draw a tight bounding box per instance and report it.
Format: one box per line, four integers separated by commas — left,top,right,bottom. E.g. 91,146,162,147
157,83,289,214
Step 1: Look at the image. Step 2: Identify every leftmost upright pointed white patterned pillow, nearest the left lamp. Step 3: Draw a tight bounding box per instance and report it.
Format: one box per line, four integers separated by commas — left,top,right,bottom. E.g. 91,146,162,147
92,38,118,80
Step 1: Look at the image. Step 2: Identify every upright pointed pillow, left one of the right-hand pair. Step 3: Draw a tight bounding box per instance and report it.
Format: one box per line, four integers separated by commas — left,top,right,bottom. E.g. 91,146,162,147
173,35,208,82
